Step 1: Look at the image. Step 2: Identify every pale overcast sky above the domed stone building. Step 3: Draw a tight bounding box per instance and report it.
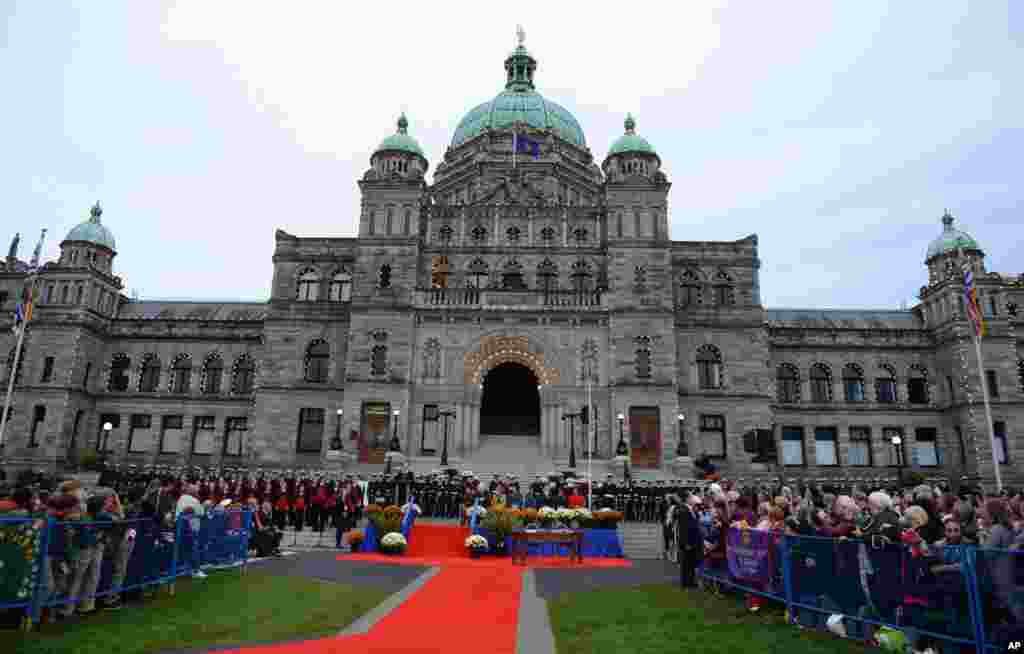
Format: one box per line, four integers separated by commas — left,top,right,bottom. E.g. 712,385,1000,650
0,0,1024,309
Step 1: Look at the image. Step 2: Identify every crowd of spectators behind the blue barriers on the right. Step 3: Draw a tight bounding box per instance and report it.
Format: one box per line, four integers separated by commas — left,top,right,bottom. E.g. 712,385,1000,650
664,480,1024,650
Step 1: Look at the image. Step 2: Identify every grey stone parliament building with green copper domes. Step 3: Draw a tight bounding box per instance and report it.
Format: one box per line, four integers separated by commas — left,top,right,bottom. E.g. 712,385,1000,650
0,41,1024,481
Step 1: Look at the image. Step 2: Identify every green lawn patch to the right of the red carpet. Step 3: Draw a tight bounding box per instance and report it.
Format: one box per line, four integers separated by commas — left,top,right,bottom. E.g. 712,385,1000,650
548,584,865,654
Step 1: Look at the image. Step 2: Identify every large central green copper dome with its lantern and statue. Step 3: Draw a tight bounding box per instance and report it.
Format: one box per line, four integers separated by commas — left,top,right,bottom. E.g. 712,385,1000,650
452,39,587,147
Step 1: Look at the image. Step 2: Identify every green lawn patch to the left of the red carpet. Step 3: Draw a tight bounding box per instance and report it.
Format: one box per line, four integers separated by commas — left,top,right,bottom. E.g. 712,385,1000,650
8,569,387,654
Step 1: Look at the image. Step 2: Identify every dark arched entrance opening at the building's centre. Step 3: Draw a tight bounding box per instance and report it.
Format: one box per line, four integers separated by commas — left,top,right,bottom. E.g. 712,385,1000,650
480,361,541,436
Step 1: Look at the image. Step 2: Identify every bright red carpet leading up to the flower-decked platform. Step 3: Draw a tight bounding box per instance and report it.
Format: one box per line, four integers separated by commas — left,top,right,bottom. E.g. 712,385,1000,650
226,525,631,654
